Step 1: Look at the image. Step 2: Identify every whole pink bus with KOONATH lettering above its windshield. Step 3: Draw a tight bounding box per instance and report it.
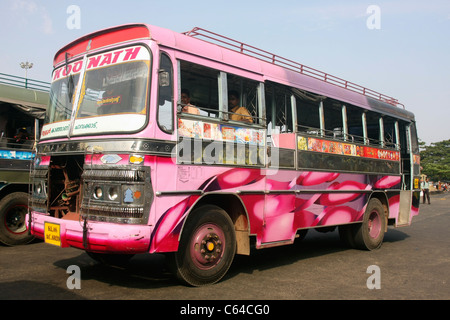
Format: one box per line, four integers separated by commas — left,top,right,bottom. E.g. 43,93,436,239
28,24,420,286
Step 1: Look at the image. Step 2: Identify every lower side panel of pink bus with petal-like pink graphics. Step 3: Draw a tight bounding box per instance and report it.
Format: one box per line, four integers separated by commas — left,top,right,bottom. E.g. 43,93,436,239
151,167,401,252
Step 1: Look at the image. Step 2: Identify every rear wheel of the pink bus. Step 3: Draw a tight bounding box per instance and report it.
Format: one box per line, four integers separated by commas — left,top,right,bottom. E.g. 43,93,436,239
339,198,386,250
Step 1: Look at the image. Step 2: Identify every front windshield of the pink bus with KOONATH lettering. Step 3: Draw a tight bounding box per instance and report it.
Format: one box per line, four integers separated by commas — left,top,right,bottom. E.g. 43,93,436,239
42,46,150,139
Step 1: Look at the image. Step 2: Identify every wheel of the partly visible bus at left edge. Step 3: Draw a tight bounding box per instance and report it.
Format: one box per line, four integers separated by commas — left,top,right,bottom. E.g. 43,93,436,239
0,192,34,246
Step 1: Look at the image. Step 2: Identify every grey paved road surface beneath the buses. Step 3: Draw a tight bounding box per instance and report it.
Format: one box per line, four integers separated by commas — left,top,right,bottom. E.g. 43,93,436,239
0,194,450,304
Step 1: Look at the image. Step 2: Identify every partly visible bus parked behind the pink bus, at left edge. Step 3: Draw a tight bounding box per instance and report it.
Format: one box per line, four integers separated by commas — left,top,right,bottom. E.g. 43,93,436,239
0,80,48,246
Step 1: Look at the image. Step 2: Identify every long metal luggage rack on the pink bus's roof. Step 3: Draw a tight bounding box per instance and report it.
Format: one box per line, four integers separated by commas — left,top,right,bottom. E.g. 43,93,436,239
182,27,405,109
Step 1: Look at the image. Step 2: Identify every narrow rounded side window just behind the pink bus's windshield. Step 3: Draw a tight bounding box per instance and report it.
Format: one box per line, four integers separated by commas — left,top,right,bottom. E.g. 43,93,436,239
158,53,173,133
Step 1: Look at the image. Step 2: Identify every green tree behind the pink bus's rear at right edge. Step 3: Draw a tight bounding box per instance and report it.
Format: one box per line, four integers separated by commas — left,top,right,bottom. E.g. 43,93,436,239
420,140,450,181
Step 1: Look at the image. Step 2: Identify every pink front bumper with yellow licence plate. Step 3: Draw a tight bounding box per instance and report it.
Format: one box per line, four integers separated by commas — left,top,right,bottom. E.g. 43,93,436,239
27,212,152,254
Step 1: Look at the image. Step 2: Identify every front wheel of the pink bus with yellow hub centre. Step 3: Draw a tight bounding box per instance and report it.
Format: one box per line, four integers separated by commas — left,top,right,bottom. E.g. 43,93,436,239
167,205,236,286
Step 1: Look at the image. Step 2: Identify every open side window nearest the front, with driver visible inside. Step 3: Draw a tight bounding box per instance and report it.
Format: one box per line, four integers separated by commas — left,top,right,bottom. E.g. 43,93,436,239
178,61,219,118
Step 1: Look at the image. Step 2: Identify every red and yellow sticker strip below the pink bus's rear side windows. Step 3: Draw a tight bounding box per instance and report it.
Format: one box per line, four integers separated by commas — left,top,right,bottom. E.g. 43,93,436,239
297,136,400,161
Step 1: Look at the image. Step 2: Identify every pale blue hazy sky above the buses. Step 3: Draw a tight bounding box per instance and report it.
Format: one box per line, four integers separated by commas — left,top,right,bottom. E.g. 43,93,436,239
0,0,450,145
